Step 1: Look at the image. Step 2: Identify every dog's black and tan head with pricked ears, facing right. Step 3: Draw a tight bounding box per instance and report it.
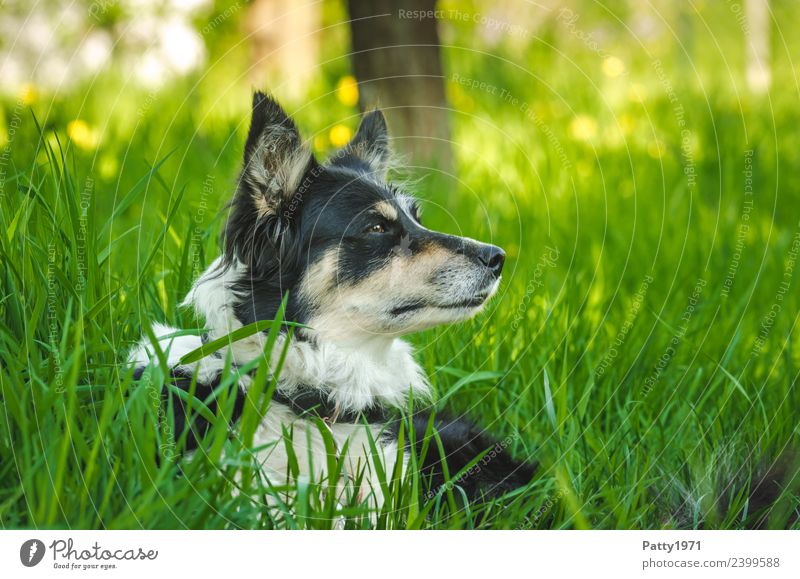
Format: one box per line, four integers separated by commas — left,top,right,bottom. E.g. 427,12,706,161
224,93,505,339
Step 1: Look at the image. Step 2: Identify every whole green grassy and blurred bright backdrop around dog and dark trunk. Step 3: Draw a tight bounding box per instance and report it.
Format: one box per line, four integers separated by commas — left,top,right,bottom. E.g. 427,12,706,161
0,0,800,528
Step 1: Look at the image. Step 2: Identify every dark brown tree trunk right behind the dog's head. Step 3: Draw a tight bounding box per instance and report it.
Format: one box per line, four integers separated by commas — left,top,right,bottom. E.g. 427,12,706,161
347,0,452,173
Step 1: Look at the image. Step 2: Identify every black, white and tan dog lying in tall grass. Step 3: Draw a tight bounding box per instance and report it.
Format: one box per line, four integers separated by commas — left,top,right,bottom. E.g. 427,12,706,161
131,93,533,505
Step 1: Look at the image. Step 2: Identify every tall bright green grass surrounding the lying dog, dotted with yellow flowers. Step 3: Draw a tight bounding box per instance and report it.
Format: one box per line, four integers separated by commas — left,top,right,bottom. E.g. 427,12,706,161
0,0,800,529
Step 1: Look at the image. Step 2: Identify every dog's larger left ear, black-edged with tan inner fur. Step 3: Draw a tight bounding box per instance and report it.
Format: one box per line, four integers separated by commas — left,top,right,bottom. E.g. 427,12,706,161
242,92,313,216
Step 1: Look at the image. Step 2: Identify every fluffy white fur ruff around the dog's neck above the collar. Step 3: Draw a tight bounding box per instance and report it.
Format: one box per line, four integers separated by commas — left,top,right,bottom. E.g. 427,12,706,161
183,258,430,413
